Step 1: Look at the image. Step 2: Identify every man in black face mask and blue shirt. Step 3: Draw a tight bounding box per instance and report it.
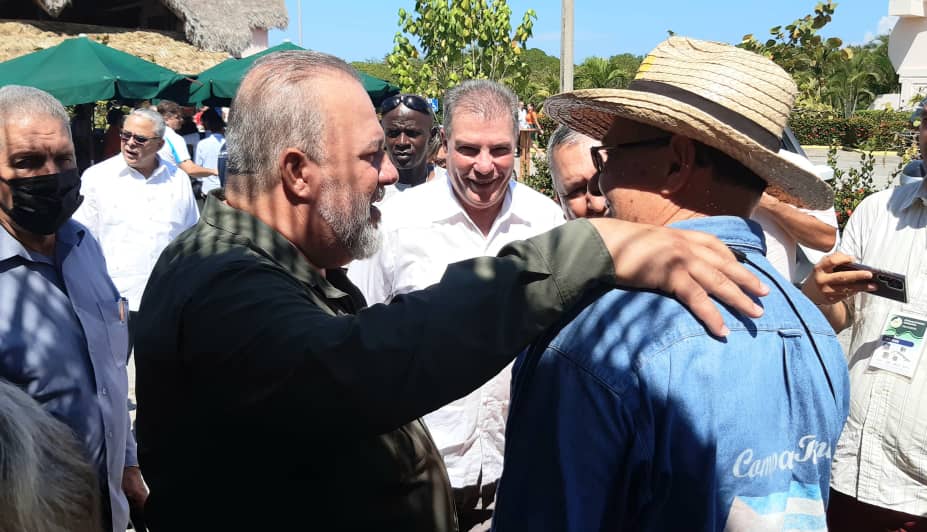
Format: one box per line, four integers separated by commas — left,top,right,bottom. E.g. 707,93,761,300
0,85,146,532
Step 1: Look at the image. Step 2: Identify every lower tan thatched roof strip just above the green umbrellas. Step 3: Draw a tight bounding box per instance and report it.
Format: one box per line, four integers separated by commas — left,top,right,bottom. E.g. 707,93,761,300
0,20,229,74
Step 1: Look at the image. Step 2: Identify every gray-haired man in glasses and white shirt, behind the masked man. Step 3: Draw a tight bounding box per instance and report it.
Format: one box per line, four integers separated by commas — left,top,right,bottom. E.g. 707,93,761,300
74,109,199,351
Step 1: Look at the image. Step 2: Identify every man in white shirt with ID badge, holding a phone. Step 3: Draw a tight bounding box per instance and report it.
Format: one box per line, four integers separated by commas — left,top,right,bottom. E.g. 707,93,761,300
802,181,927,532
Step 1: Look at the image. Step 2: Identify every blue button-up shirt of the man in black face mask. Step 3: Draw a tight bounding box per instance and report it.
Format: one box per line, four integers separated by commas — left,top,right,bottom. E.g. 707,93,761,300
0,221,138,532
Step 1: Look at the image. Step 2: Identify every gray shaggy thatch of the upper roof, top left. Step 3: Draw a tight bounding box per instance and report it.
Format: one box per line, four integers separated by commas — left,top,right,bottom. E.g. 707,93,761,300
29,0,287,56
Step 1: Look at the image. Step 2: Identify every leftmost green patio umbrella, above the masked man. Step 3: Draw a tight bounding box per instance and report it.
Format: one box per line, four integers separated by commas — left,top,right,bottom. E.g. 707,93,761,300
0,36,185,105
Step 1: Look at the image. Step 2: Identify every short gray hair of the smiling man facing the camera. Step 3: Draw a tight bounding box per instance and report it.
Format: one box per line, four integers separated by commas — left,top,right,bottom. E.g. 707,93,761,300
444,79,518,143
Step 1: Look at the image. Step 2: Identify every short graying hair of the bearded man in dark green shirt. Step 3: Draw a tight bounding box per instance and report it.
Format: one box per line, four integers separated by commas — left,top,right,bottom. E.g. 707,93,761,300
226,50,360,198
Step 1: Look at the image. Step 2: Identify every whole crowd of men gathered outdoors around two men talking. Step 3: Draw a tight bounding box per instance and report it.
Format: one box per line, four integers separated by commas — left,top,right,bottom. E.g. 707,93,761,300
0,36,927,532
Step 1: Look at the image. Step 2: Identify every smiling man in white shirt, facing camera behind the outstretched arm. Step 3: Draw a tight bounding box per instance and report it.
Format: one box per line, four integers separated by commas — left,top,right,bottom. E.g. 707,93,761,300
348,80,564,530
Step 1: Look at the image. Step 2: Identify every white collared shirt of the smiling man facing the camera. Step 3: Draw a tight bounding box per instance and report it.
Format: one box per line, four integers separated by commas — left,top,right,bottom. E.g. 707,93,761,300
348,175,564,488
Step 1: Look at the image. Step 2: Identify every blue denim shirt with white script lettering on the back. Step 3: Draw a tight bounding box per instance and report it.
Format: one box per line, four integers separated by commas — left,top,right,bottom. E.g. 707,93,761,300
493,217,848,532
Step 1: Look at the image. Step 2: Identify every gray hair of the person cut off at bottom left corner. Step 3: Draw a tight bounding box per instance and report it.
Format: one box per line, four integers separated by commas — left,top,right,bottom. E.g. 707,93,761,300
0,380,102,532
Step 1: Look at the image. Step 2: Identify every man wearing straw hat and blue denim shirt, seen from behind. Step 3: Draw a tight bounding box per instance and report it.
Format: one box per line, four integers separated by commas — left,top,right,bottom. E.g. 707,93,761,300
494,37,848,531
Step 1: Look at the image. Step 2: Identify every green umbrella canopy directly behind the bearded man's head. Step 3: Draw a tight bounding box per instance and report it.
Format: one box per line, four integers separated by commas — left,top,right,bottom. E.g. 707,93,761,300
189,42,399,107
